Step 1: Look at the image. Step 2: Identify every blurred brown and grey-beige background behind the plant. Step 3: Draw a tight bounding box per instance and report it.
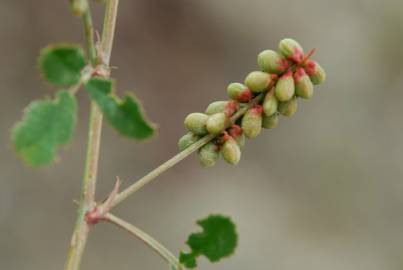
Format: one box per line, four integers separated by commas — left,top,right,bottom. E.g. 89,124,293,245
0,0,403,270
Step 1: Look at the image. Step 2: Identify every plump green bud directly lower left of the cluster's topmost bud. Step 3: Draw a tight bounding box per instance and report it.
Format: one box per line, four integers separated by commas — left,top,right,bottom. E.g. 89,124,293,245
257,50,290,74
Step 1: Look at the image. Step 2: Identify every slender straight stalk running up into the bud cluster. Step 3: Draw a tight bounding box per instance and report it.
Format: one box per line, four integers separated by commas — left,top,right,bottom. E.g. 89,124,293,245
112,93,265,207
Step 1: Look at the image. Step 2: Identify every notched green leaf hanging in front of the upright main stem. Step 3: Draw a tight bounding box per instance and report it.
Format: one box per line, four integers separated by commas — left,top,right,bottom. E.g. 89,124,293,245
85,78,155,140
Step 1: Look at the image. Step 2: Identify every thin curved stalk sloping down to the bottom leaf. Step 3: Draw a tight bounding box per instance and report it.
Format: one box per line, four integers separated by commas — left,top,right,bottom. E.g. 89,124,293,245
104,213,181,269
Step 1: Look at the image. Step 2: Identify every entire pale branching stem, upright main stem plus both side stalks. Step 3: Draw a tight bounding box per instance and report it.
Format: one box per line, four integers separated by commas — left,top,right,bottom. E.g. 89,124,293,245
65,0,265,270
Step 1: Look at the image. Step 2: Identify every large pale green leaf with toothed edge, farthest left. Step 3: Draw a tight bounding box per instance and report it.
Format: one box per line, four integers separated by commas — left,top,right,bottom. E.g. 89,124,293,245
12,91,77,167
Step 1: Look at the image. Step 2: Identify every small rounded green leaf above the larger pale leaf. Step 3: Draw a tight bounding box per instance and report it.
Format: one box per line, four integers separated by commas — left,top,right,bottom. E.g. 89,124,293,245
39,44,86,86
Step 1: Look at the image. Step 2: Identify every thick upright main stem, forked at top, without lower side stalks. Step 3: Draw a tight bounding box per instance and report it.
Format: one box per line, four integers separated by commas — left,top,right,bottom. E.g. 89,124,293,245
64,0,119,270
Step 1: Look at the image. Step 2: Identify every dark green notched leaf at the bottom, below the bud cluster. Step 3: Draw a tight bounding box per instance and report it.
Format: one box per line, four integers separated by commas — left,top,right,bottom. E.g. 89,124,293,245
179,215,238,268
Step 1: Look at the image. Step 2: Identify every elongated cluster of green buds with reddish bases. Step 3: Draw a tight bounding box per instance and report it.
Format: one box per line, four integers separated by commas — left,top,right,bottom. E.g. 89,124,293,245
178,38,326,167
